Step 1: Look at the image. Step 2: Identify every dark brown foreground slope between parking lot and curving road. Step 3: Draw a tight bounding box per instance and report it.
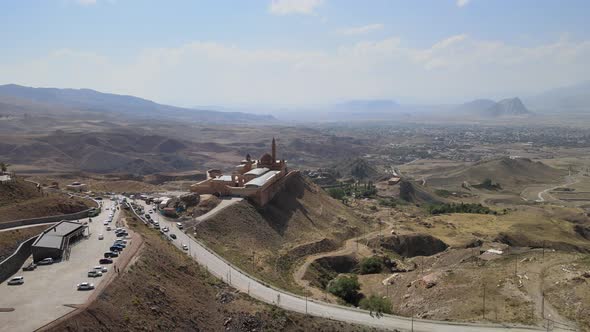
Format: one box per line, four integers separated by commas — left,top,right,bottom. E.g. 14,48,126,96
51,215,384,332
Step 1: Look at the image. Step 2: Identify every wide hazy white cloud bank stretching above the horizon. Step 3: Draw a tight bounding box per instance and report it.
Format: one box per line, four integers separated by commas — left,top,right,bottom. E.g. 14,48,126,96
0,34,590,105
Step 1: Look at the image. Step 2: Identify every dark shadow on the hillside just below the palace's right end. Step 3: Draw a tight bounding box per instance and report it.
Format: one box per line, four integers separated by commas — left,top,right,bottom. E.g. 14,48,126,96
260,175,313,236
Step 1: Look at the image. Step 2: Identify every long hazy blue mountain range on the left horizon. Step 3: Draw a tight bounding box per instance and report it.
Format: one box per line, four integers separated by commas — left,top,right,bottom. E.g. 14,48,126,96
0,84,275,123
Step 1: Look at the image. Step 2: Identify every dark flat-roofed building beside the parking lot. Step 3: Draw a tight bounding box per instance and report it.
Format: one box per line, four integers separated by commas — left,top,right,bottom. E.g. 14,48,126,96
31,220,87,262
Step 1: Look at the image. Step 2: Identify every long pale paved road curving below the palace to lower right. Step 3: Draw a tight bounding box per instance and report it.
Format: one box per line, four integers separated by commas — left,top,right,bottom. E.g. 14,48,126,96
137,201,556,332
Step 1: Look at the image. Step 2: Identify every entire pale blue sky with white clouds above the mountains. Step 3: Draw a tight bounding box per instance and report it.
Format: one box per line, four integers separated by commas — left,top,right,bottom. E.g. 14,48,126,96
0,0,590,107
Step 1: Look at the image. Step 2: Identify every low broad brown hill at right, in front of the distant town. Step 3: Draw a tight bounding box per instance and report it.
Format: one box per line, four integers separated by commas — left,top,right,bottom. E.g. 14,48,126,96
428,157,566,189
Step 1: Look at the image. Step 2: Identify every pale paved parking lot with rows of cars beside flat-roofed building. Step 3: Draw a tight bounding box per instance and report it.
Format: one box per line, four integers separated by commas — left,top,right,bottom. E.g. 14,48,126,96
0,200,129,331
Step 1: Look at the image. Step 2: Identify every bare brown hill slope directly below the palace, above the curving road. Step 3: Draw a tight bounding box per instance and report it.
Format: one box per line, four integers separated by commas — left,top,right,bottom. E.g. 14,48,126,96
196,176,364,291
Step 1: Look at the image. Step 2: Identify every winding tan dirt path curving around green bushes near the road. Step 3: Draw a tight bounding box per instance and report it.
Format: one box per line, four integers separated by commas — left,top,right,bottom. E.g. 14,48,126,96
293,219,392,303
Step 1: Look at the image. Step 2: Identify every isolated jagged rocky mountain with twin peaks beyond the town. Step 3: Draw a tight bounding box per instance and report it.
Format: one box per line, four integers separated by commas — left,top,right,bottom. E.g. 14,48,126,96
454,97,532,118
